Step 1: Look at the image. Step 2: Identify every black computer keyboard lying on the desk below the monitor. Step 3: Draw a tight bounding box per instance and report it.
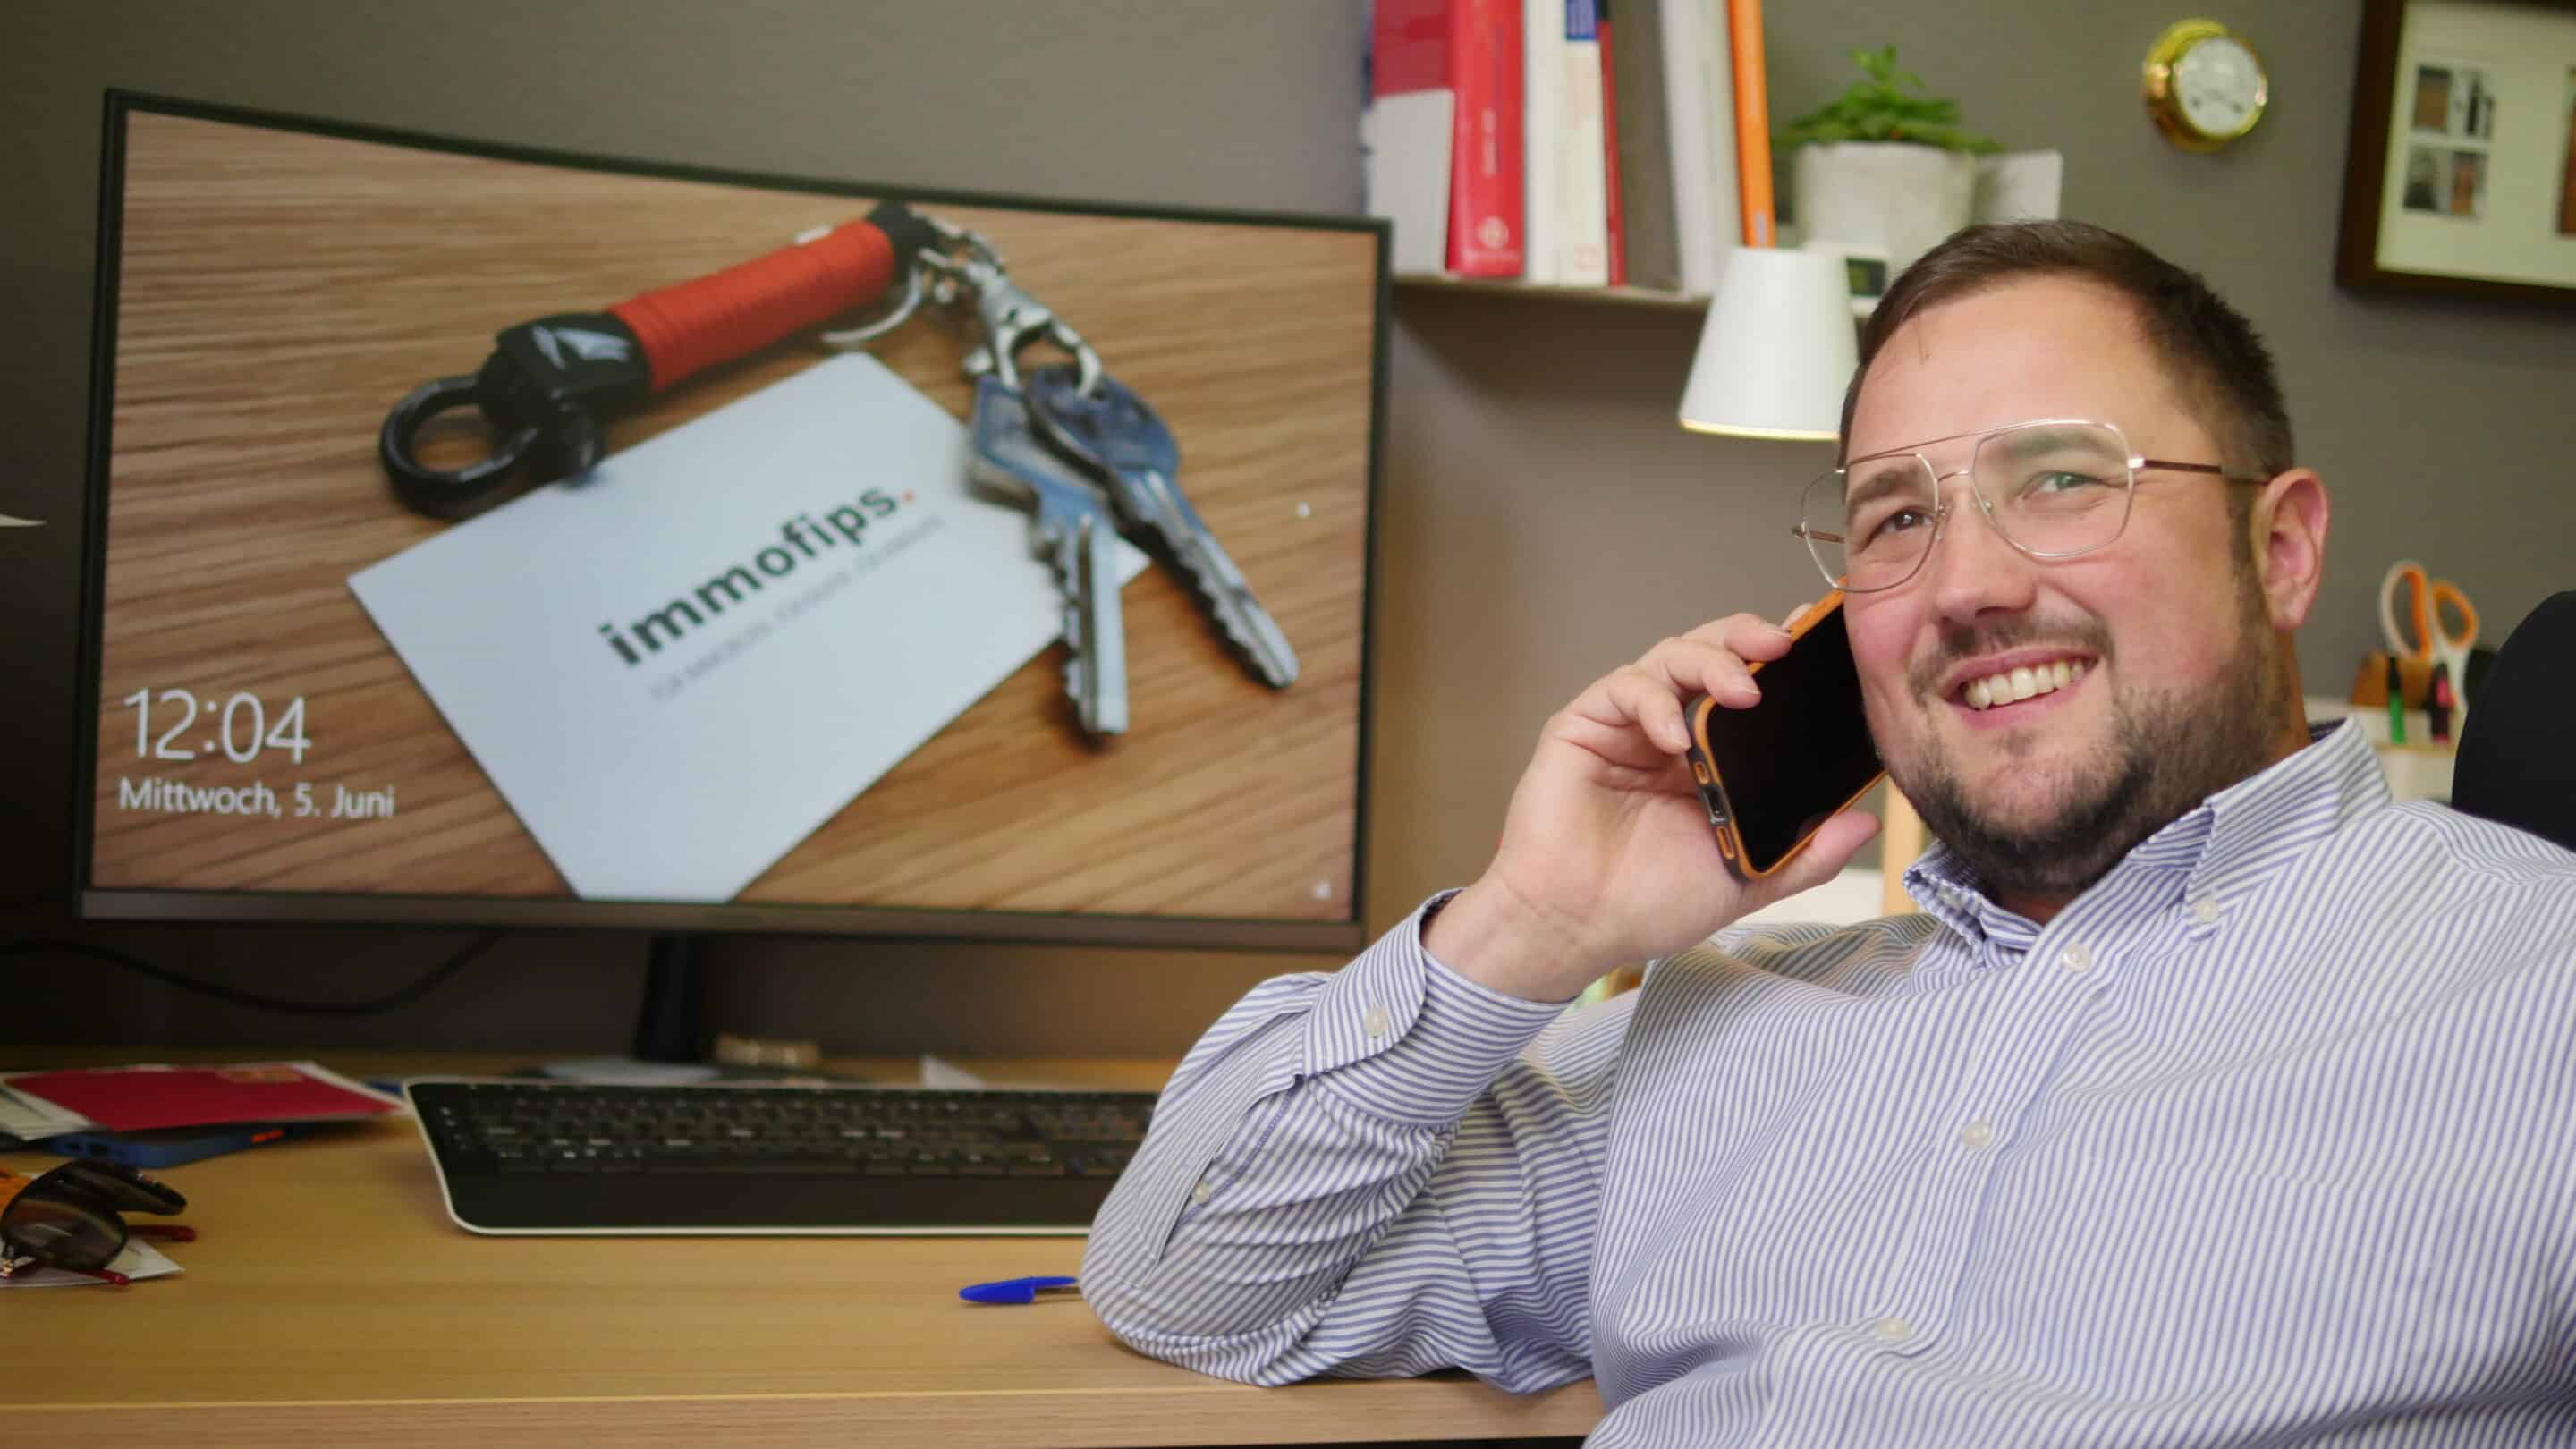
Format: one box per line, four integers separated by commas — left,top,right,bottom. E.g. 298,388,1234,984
404,1080,1154,1233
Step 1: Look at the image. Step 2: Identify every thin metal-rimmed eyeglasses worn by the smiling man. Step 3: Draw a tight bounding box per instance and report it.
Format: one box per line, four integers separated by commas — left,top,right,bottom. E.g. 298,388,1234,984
1791,418,2269,593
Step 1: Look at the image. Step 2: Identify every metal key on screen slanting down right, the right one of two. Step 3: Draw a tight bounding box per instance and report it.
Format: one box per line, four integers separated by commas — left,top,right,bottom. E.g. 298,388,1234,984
1020,363,1296,689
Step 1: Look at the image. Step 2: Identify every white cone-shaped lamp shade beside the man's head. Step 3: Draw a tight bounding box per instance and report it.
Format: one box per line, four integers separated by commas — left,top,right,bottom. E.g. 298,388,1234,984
1682,248,1860,444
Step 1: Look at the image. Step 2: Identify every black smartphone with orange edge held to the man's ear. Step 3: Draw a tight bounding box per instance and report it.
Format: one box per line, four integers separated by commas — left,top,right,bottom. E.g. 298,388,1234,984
1690,590,1885,879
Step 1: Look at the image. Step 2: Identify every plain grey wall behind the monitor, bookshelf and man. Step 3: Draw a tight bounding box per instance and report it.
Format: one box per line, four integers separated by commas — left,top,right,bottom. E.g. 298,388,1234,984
0,0,2576,1055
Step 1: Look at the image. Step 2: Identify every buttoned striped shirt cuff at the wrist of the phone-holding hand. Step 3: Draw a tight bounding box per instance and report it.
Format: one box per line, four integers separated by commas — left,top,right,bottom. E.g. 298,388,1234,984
1301,894,1566,1127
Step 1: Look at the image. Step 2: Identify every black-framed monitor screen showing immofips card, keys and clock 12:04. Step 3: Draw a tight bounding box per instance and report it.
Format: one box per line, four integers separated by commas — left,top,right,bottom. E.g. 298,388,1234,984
75,93,1385,949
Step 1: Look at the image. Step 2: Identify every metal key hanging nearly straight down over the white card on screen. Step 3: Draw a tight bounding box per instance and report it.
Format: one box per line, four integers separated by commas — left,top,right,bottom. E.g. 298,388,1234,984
969,377,1126,737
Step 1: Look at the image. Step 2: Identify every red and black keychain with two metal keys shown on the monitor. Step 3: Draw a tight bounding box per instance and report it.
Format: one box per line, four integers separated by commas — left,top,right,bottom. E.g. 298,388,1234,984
378,201,1299,740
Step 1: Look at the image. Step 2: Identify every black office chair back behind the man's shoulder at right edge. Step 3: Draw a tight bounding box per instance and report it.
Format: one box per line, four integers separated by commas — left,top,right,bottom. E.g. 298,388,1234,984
2450,590,2576,851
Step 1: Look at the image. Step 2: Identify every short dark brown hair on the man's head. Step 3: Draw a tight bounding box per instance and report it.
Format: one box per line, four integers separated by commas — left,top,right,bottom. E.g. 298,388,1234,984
1842,222,2292,479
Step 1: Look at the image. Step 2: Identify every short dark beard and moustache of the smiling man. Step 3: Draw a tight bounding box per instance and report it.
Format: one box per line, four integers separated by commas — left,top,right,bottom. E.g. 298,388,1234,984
1888,575,2280,897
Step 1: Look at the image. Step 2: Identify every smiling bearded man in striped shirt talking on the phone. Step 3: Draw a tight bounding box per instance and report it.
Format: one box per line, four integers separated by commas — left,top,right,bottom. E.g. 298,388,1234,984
1082,222,2576,1446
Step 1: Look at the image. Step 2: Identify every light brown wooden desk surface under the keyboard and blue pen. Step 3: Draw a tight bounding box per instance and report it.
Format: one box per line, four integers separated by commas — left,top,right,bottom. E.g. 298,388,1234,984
0,1049,1599,1449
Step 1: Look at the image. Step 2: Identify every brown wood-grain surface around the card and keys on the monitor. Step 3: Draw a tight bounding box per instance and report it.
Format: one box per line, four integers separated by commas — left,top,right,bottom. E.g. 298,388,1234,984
88,108,1378,920
